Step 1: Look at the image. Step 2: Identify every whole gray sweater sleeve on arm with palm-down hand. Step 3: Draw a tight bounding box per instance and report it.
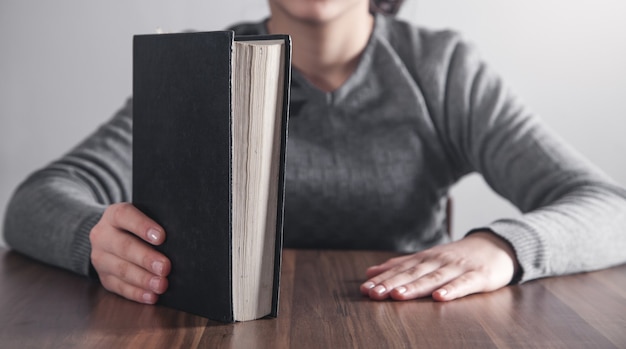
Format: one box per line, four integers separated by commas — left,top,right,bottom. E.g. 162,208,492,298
442,38,626,282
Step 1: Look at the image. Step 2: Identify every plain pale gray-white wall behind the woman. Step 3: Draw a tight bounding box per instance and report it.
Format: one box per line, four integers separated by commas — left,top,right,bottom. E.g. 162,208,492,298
0,0,626,245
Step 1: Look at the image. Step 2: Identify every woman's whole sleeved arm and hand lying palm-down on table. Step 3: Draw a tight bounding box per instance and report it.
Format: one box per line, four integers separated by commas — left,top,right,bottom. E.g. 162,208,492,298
361,31,626,300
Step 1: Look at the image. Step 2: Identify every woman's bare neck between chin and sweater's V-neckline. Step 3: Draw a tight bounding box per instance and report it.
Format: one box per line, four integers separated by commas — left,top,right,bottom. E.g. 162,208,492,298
268,8,374,92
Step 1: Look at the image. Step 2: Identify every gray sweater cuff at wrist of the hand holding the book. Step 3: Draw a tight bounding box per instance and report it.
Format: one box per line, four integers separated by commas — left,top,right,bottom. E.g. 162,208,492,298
71,210,104,277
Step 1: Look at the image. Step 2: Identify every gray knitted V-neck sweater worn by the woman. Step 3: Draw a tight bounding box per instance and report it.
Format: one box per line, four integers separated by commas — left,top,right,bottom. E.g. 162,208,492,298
4,15,626,281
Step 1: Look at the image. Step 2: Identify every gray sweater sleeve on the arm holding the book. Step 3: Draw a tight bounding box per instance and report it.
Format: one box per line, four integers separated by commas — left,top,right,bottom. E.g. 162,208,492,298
4,100,132,275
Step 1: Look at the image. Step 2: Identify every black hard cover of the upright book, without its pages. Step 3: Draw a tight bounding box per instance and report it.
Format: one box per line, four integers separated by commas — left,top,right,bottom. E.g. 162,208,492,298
133,31,291,322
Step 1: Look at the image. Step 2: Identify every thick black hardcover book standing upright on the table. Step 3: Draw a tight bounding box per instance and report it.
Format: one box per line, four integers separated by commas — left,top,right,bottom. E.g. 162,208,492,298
132,31,291,322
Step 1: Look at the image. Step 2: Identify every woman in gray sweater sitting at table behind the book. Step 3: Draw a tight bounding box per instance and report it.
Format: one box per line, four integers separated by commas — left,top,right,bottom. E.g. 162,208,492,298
5,0,626,303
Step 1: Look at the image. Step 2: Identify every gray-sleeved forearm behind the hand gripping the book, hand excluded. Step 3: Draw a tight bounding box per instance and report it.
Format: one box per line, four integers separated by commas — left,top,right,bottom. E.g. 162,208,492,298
4,170,104,275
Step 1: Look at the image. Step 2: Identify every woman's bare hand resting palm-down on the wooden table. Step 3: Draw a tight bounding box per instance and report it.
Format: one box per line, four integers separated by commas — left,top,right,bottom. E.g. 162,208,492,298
361,232,519,301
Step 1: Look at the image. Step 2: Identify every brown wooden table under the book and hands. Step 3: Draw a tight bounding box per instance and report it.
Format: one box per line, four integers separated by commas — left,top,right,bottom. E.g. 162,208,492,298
0,249,626,349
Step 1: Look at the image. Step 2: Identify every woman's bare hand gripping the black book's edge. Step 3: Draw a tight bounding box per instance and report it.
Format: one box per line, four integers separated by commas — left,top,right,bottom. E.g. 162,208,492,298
89,203,171,304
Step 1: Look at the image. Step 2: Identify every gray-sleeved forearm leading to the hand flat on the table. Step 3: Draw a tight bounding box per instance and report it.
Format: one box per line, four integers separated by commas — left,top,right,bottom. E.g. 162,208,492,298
488,184,626,282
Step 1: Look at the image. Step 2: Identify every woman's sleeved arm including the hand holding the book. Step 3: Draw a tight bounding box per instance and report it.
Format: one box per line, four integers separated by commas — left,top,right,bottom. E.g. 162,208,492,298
4,100,171,303
